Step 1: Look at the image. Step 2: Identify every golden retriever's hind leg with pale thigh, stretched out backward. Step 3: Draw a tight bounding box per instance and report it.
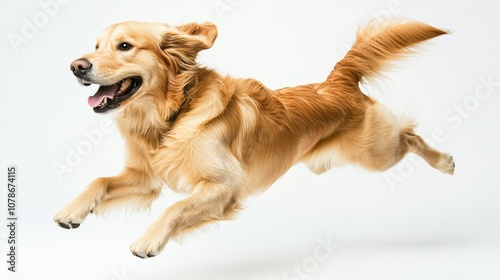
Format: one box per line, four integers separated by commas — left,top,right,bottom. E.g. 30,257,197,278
302,102,455,174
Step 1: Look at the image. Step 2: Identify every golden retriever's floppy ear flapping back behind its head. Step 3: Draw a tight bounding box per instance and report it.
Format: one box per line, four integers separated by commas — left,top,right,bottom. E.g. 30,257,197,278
162,22,217,56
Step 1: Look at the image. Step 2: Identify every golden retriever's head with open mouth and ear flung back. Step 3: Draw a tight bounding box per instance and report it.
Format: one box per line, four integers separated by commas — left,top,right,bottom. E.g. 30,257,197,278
70,22,217,113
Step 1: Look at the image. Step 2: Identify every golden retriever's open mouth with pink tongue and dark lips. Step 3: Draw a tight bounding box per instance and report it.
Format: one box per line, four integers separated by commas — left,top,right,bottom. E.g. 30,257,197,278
84,77,142,113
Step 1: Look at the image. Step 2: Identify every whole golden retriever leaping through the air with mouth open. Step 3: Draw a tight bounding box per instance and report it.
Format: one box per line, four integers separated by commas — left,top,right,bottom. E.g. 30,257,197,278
54,18,455,258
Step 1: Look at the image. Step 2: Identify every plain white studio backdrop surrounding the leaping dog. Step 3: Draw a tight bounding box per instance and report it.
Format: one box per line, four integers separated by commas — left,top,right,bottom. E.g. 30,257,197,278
0,0,500,280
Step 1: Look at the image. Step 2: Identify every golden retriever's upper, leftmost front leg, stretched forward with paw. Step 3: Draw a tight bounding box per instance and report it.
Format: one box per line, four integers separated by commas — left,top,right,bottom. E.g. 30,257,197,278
54,168,161,229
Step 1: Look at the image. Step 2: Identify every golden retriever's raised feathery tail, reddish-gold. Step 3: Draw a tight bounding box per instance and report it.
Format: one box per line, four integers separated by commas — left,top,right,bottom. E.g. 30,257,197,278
327,20,448,87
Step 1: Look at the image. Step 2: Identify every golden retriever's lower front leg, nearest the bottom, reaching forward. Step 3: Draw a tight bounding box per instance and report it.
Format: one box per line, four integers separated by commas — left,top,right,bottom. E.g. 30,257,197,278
130,183,239,258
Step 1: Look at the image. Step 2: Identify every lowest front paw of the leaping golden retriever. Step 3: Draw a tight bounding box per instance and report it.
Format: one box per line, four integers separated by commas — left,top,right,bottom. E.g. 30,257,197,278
130,230,168,259
